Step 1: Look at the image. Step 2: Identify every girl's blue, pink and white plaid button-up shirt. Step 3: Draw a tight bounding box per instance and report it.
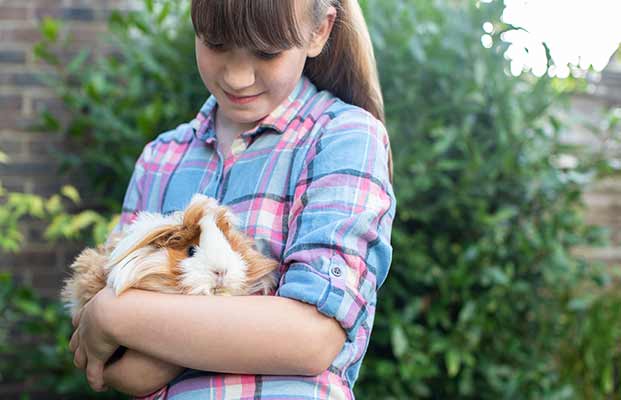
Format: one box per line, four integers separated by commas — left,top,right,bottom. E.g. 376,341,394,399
117,76,396,400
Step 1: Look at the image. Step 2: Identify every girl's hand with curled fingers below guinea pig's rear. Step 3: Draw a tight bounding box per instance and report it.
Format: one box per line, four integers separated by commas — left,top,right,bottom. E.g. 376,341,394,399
69,287,119,392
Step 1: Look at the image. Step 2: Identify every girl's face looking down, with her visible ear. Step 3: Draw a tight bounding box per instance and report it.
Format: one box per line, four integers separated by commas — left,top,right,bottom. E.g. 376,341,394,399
195,4,336,130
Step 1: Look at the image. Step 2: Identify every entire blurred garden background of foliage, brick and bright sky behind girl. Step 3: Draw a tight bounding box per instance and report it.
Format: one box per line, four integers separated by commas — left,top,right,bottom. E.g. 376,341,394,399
0,0,621,399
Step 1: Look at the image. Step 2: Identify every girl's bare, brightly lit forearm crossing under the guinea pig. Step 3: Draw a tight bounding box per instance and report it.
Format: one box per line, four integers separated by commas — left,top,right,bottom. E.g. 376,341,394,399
95,289,345,380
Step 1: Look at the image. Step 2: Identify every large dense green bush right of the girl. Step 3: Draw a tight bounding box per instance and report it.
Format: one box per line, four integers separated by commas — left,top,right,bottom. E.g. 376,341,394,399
357,0,619,399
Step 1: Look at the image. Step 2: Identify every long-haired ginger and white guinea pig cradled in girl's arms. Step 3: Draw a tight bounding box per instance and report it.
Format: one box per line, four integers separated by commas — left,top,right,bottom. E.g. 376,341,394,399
61,194,278,316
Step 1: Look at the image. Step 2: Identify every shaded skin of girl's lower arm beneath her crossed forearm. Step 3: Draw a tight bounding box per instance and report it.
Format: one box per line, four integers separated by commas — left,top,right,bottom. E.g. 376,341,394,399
104,349,184,397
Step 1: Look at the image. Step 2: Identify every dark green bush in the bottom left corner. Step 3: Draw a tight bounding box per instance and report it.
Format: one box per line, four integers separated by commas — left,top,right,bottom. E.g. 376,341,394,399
0,273,124,400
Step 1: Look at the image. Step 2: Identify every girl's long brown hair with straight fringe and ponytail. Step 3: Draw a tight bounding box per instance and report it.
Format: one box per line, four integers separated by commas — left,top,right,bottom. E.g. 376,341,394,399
192,0,392,181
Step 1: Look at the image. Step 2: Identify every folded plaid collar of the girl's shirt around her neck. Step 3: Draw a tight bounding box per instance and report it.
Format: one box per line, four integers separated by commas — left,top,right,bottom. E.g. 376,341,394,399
190,75,317,142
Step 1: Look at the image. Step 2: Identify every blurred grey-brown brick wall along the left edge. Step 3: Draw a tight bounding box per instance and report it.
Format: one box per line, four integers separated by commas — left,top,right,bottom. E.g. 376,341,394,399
0,0,136,296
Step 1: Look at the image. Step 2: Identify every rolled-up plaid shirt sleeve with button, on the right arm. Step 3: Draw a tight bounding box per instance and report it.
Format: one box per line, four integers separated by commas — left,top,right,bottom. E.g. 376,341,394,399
276,109,396,341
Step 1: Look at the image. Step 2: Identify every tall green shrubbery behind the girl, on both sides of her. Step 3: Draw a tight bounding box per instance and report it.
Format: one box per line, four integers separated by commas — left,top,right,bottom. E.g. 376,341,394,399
23,0,621,399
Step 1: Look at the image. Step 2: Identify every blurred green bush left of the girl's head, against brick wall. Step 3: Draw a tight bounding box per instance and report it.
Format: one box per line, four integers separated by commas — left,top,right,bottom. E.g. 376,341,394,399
34,1,203,212
